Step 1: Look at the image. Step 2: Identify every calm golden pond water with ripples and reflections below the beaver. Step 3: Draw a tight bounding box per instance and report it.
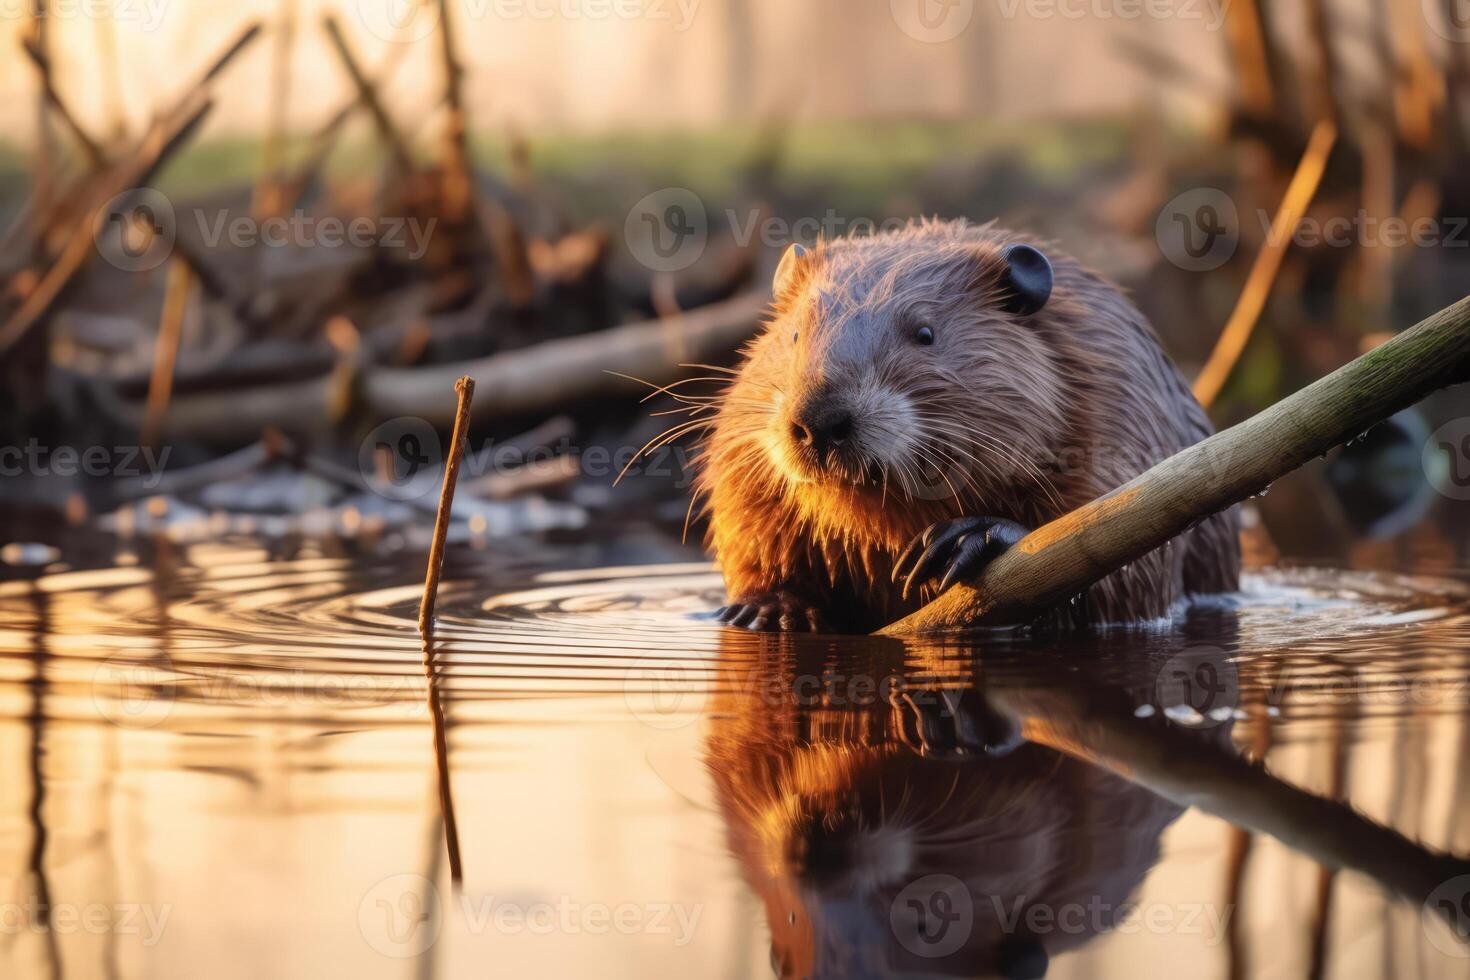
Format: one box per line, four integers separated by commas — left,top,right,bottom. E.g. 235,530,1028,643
0,531,1470,980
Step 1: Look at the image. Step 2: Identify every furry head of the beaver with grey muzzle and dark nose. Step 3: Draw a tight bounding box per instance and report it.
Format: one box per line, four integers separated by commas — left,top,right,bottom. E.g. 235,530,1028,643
728,222,1066,540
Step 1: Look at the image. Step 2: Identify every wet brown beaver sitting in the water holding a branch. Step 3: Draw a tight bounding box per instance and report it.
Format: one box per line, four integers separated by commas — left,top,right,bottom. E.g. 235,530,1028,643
695,220,1241,632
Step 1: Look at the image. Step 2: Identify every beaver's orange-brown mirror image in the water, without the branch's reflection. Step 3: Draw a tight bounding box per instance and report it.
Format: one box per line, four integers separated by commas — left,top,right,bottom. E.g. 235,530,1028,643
707,640,1223,977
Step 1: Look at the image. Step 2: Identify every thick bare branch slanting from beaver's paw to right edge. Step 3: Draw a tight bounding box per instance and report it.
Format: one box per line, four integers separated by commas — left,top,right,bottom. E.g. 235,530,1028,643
881,297,1470,635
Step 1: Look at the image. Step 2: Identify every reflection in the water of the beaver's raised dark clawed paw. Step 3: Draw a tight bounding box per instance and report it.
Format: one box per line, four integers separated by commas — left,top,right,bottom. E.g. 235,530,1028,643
888,688,1026,761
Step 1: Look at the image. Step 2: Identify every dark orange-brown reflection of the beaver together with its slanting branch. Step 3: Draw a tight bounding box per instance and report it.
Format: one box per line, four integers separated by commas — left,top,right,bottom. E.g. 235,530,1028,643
707,628,1467,977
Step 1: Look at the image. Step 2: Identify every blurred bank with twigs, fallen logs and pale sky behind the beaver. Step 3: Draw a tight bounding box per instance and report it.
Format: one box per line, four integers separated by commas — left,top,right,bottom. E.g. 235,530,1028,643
0,0,1470,564
